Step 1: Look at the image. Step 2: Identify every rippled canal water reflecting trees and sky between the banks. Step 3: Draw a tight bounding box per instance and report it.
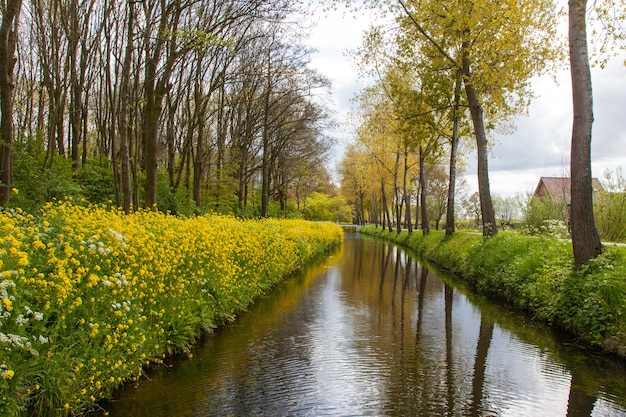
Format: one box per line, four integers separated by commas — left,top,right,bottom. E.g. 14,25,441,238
97,233,626,417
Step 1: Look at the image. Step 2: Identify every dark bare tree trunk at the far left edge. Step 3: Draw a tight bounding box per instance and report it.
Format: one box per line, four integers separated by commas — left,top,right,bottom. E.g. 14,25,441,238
0,0,22,205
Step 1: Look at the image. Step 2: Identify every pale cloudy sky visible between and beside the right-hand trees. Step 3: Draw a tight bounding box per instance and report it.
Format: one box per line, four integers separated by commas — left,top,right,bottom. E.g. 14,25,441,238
300,3,626,196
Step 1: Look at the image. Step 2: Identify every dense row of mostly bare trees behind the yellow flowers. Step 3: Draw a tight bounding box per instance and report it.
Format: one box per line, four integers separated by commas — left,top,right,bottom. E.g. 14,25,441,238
0,0,331,216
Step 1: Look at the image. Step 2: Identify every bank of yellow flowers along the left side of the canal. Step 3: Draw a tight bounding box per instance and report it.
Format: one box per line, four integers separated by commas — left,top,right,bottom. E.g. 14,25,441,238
0,202,343,416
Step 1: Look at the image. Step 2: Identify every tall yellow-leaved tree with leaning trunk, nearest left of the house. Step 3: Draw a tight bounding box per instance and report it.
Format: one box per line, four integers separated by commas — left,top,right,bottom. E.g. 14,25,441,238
398,0,556,236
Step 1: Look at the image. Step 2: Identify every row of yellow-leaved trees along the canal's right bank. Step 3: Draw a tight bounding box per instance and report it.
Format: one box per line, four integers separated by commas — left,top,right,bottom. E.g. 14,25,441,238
341,0,626,265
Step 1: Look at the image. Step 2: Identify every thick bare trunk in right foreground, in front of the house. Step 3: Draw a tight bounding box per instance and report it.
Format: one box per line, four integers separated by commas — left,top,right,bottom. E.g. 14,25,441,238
569,0,602,266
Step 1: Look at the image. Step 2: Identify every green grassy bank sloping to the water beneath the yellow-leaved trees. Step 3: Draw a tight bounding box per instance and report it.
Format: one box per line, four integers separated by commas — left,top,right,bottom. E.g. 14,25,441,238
361,226,626,358
